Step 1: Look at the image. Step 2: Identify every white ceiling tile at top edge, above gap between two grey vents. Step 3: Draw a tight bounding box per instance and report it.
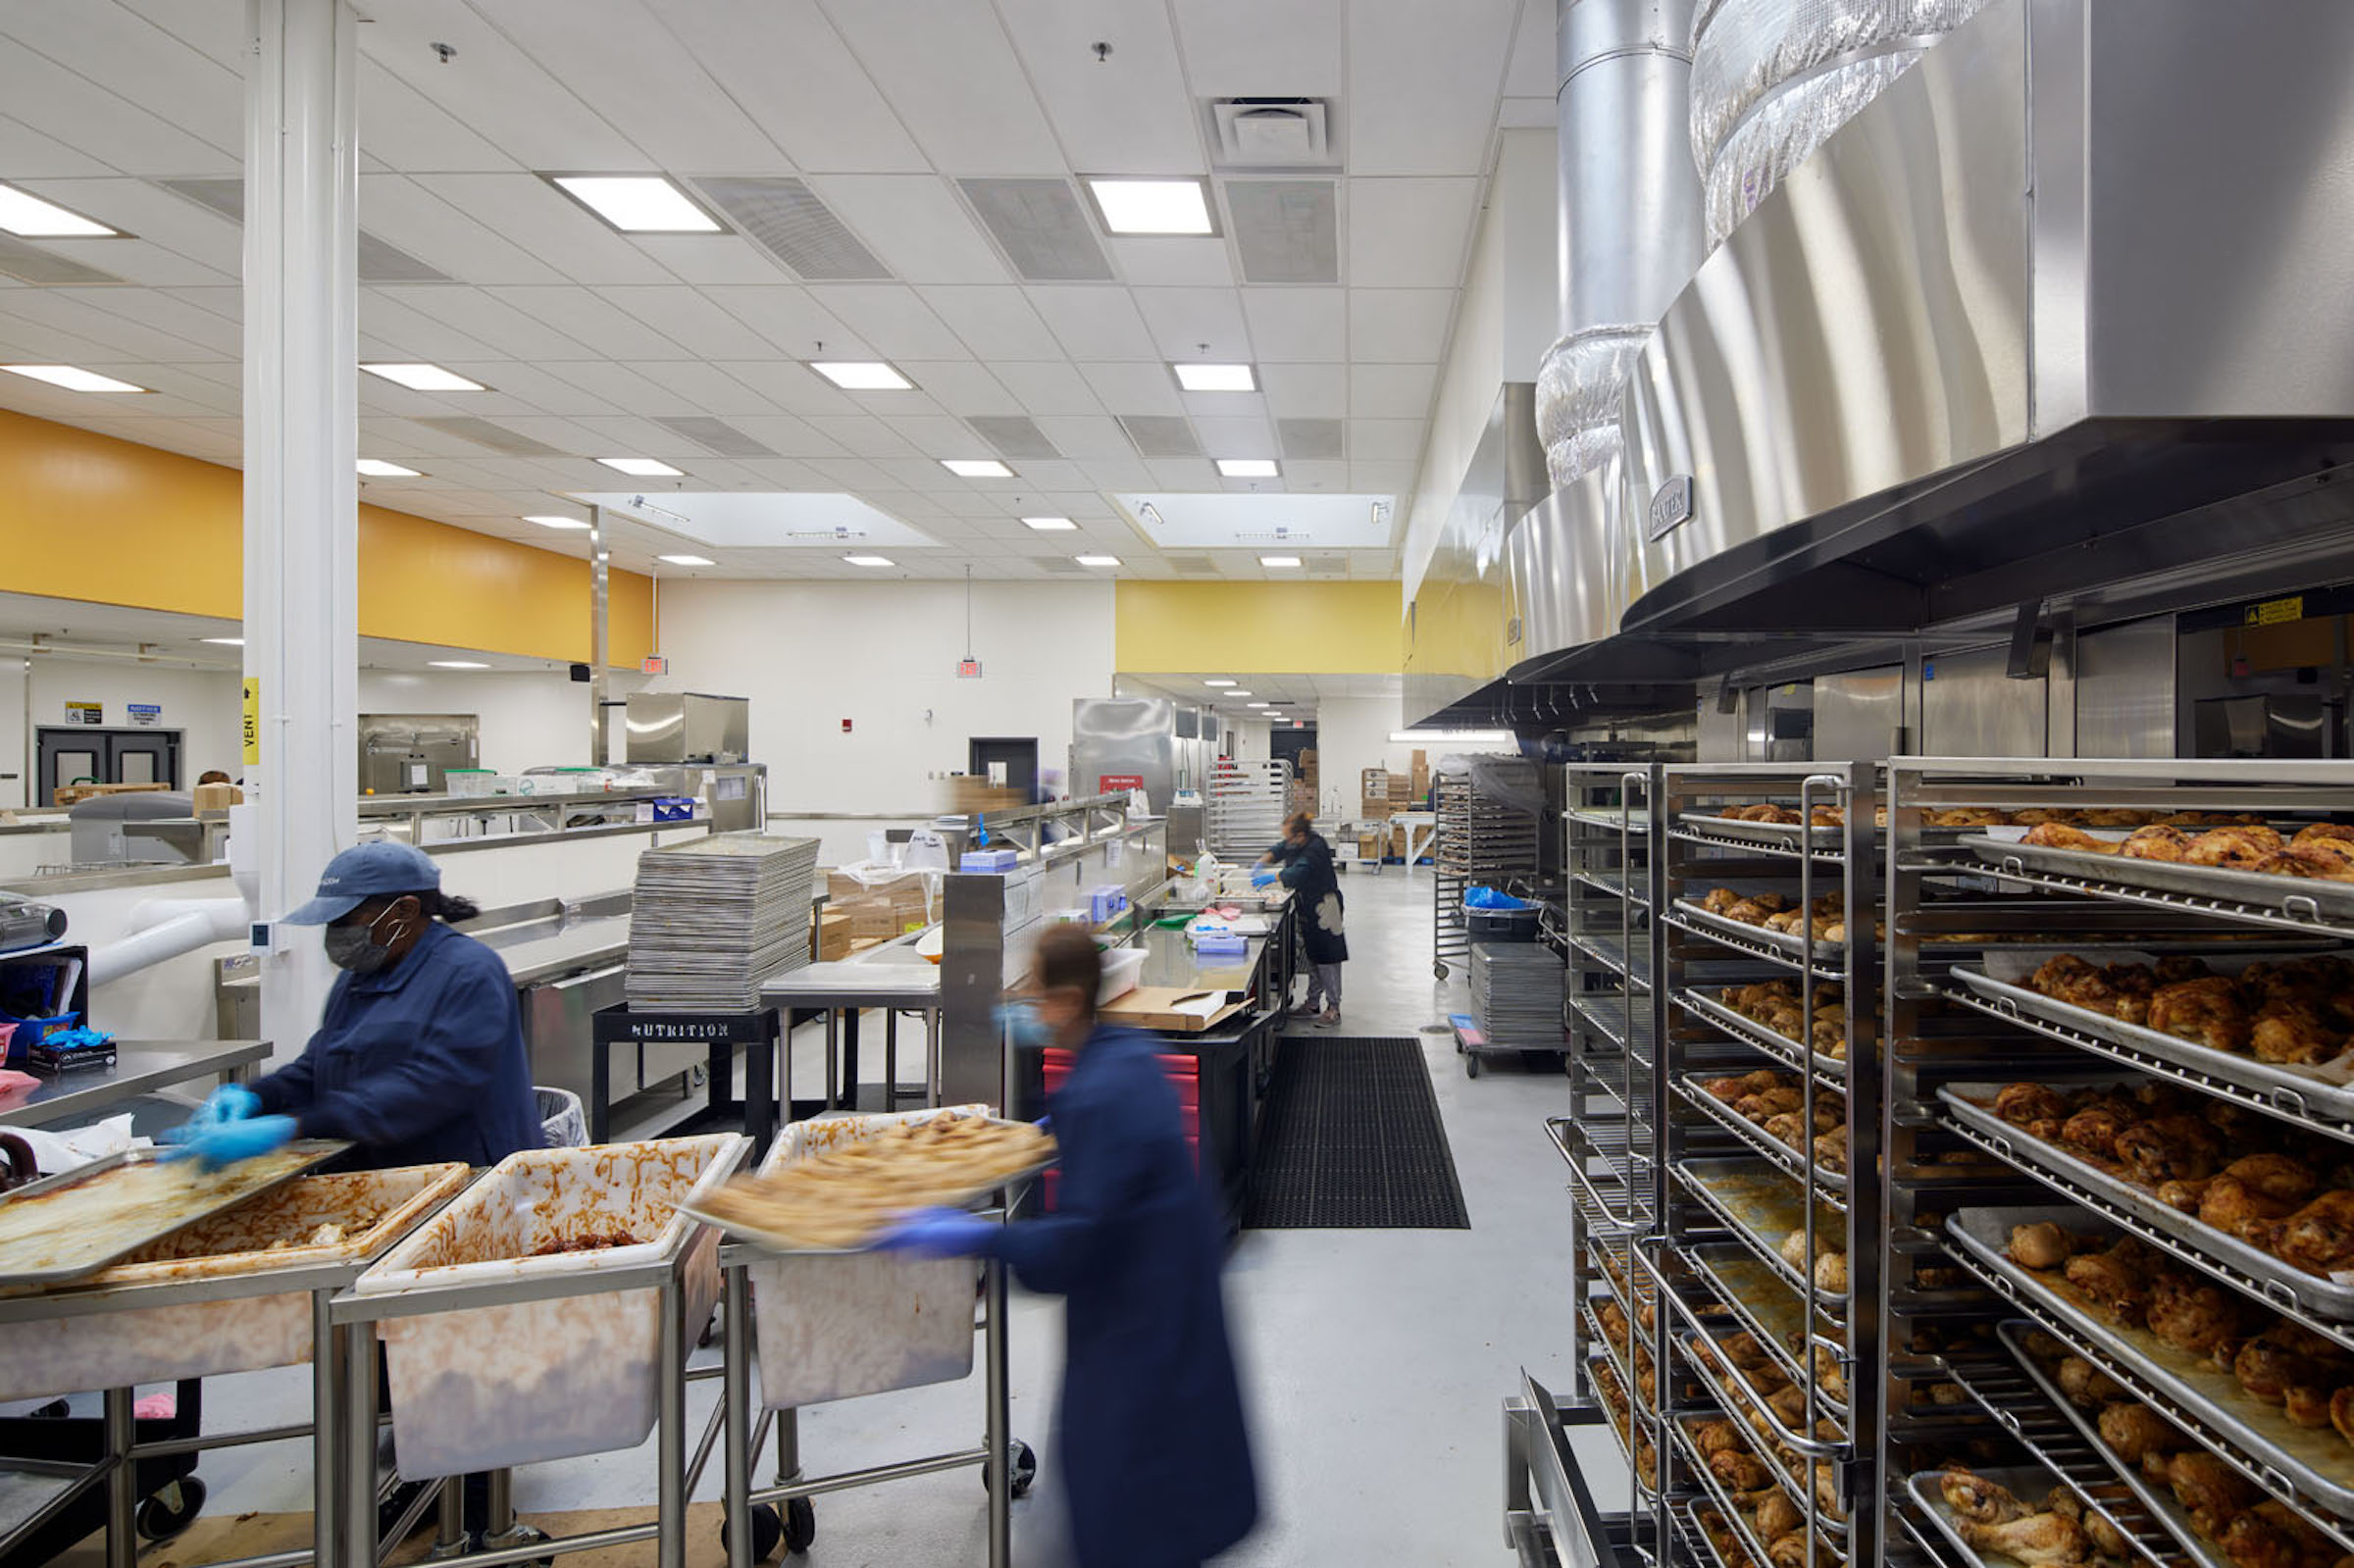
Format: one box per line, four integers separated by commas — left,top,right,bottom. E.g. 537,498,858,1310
661,0,928,175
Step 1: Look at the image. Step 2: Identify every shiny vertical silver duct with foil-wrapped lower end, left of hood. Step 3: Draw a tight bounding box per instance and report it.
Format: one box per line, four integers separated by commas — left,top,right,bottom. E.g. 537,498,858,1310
1537,0,1707,487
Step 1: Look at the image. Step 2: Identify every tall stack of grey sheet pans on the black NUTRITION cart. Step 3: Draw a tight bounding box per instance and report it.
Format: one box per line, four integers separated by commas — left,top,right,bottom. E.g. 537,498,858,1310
626,834,817,1012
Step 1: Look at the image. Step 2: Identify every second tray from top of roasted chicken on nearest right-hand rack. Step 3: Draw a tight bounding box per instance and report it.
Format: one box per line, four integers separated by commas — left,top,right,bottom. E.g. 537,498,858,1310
1952,949,2354,1121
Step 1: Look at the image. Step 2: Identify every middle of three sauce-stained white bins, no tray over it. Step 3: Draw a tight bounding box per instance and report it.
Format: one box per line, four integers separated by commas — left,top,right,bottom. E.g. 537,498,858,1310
353,1133,751,1479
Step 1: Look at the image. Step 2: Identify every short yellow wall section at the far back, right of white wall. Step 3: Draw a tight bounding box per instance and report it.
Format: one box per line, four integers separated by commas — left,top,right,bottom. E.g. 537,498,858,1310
1111,582,1406,676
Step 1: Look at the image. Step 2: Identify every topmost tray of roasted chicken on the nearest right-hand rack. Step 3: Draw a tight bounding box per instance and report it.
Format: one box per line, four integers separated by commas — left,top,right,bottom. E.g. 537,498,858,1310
1961,822,2354,916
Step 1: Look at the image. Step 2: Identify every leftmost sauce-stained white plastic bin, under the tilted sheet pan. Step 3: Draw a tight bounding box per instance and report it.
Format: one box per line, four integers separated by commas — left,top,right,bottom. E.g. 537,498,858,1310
0,1165,469,1398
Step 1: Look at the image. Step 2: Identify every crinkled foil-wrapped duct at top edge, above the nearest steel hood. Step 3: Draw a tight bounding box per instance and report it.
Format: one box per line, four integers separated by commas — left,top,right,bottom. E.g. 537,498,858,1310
1690,0,1984,249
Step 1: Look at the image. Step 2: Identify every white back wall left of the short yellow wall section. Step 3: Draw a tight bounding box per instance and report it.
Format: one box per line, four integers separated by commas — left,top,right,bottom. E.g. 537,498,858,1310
649,582,1113,815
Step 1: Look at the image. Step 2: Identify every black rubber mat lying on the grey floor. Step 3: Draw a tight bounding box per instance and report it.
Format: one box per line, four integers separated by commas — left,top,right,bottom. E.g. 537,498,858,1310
1243,1036,1471,1232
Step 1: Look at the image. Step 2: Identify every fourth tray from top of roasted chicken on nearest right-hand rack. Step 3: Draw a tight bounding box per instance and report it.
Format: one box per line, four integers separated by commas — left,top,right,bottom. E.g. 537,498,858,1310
1947,1205,2354,1516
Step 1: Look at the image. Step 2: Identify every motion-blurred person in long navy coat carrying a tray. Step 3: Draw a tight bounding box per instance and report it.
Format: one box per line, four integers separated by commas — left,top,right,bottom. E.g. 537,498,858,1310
883,928,1259,1568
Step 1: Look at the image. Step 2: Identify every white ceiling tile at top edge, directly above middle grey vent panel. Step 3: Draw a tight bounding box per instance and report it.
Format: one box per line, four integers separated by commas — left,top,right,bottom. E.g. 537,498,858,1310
829,0,1059,175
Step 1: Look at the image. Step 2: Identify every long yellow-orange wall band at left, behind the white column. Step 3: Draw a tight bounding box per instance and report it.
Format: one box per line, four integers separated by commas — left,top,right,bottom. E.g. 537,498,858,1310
0,410,654,669
